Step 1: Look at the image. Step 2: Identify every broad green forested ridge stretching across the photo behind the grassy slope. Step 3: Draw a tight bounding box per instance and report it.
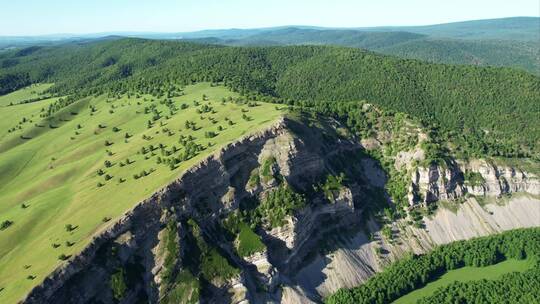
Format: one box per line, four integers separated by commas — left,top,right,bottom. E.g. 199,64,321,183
0,38,540,157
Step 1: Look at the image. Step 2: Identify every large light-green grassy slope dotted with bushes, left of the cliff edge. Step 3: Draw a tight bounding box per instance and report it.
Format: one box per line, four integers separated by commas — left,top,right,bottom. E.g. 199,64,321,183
0,84,283,303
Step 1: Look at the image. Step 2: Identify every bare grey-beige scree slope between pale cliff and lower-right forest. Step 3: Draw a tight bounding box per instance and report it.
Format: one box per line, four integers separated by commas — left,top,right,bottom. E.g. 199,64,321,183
294,195,540,303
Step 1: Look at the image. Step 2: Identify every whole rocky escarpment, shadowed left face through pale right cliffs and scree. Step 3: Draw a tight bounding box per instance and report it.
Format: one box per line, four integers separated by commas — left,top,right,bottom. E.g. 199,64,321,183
23,119,540,303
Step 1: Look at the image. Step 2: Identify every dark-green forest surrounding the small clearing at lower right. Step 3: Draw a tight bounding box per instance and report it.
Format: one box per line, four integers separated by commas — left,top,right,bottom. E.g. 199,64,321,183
326,228,540,304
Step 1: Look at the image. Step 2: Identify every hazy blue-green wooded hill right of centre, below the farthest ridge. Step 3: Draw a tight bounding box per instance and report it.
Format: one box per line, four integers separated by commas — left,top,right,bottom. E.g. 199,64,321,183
215,27,540,75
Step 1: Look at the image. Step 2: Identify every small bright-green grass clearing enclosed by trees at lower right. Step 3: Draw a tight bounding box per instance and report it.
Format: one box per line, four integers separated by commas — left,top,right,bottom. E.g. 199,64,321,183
394,259,534,304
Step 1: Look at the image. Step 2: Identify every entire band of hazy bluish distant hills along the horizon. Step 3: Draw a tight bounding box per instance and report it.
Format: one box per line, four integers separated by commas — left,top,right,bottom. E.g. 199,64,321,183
0,17,540,75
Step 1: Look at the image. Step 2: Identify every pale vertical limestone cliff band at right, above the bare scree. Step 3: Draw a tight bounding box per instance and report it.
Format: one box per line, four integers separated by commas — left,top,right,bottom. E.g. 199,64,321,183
409,160,540,205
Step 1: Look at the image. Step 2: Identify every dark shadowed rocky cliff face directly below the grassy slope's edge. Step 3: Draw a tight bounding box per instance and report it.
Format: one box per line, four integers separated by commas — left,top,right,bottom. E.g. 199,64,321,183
24,119,368,303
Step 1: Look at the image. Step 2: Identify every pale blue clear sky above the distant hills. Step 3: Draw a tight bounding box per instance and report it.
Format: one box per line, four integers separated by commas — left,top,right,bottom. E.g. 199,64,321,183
0,0,540,35
